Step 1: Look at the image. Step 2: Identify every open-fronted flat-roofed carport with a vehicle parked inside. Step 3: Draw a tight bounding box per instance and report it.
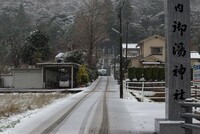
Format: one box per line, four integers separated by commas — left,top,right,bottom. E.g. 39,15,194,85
37,62,80,88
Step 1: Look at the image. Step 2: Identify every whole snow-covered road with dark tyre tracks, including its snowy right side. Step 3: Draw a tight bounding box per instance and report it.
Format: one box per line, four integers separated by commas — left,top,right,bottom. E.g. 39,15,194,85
3,77,165,134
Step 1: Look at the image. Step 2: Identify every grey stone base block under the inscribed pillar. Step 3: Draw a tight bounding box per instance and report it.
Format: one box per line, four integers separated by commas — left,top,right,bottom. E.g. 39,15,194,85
155,119,199,134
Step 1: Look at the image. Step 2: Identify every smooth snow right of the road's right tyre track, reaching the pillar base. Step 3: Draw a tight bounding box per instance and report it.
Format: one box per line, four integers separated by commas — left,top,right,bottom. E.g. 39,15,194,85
108,78,165,134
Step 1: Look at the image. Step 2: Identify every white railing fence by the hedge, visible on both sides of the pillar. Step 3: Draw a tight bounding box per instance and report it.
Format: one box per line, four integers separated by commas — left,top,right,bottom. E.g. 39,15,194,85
123,81,200,101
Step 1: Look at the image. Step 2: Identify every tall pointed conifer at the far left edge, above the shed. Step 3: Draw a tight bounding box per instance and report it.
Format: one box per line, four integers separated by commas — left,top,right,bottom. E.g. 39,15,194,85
0,4,30,67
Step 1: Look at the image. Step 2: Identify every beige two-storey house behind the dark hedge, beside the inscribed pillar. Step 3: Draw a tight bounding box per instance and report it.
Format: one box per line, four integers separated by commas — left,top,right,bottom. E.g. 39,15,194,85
129,35,200,67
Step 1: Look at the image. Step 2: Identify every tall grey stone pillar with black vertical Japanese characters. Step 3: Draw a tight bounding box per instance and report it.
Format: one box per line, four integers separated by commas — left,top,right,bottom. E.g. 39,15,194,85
165,0,191,121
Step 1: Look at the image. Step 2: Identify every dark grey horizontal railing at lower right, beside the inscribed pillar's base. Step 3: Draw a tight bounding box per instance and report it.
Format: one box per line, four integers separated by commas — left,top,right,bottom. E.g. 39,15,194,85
180,101,200,134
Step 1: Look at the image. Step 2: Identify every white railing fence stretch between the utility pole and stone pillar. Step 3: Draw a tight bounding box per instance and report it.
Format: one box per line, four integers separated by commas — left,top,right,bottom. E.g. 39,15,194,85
123,81,165,101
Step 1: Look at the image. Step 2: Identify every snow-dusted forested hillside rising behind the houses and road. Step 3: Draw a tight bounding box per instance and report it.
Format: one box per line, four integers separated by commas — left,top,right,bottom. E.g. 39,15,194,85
0,0,200,72
